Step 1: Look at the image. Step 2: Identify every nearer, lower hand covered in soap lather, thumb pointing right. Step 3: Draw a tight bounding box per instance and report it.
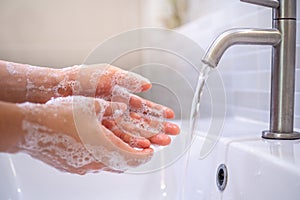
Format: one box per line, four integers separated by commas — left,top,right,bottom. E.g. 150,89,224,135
19,96,153,174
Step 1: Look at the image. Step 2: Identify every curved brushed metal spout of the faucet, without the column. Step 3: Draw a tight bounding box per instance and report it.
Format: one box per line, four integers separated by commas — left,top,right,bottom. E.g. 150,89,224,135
202,28,281,68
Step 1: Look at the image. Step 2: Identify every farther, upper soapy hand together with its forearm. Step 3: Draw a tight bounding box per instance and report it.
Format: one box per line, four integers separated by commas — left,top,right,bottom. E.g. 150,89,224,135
0,61,179,170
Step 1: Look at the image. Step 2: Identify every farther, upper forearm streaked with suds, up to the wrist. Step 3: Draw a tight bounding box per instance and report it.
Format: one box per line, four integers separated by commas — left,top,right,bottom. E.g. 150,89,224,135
0,61,66,103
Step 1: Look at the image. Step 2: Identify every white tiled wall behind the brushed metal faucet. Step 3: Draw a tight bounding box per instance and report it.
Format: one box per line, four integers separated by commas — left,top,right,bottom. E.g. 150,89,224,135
178,0,300,128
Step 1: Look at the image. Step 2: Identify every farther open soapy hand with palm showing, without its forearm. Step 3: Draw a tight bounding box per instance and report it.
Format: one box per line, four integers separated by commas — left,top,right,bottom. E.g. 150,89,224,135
58,64,179,148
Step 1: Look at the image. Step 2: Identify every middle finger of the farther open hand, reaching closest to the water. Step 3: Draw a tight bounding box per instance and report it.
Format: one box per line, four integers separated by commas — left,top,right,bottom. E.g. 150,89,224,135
130,112,180,135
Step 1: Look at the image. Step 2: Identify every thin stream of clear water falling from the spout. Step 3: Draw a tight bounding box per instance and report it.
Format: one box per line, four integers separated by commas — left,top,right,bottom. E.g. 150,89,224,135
190,65,212,135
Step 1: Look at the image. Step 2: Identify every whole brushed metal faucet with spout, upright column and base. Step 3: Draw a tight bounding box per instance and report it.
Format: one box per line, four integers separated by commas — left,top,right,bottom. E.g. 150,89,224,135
202,0,300,139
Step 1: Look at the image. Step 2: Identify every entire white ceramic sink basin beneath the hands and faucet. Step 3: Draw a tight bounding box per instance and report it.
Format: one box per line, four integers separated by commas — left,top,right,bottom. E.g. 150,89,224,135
0,118,300,200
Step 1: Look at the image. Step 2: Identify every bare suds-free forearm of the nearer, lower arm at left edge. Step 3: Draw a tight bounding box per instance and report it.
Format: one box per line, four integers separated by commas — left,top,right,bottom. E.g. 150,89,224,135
0,101,24,152
